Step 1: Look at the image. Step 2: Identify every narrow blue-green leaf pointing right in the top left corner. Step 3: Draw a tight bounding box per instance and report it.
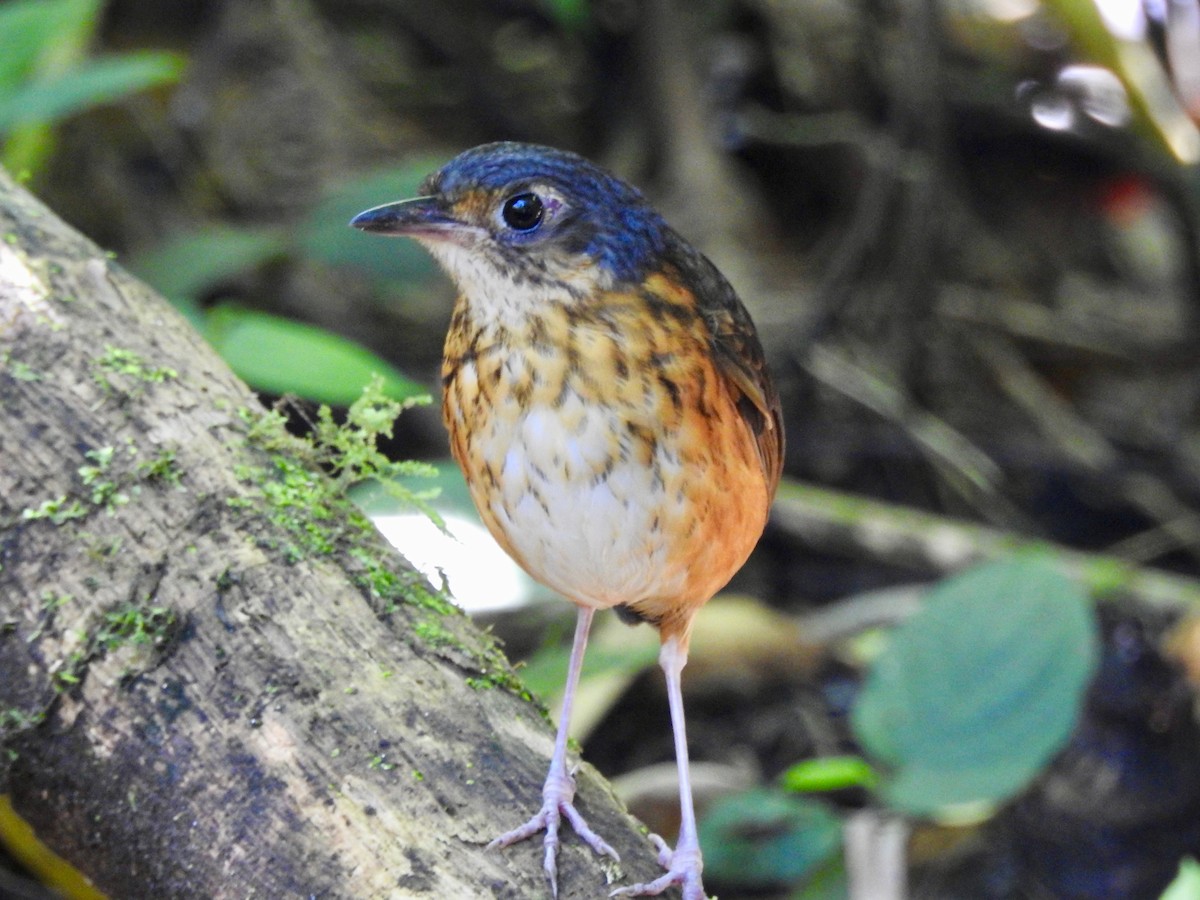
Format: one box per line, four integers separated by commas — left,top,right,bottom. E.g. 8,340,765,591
0,52,184,132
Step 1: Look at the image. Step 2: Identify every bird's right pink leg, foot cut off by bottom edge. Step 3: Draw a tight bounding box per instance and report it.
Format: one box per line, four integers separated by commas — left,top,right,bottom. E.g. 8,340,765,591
608,637,708,900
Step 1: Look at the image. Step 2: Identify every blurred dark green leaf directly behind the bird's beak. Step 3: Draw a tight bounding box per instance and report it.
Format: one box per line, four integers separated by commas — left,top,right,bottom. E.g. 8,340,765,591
296,164,444,281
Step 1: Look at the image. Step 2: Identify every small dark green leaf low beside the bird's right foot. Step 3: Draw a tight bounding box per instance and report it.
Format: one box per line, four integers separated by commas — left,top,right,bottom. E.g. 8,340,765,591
700,788,841,889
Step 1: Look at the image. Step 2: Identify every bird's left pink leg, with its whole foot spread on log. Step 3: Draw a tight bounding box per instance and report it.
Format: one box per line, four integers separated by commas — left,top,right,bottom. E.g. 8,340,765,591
487,606,620,896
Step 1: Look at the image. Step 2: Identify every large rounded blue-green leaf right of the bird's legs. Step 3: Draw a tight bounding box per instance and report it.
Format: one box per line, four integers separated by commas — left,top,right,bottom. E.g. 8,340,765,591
852,557,1099,815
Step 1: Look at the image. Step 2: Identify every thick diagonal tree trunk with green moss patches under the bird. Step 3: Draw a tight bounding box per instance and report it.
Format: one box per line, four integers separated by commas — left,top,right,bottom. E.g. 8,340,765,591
0,173,656,898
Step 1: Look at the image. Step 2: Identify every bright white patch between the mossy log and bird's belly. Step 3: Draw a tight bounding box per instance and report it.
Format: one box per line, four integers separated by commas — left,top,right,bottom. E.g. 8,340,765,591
373,514,533,613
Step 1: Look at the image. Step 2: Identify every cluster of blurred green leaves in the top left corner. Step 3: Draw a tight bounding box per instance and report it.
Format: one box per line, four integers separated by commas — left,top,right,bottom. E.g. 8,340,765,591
0,0,184,172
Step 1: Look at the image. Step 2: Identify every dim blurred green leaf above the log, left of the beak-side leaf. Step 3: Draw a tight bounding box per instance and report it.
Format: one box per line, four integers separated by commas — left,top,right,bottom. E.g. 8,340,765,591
130,226,288,300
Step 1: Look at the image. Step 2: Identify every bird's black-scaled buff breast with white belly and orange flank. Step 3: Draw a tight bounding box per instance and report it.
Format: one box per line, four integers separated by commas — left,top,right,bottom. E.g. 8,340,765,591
443,282,769,637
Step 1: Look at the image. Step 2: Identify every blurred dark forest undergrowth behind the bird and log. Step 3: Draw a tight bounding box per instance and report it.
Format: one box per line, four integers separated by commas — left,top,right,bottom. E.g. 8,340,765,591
7,0,1200,898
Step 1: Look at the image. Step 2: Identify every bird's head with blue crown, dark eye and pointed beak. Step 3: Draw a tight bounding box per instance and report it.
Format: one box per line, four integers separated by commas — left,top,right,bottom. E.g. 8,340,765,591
350,143,668,299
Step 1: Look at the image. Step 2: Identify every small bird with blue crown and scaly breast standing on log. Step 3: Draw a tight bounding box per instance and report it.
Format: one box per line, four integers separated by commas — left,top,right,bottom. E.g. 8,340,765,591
350,142,784,900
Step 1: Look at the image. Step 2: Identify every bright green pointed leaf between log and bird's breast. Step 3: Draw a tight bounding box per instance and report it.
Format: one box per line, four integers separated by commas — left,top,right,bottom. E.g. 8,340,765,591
204,304,426,407
